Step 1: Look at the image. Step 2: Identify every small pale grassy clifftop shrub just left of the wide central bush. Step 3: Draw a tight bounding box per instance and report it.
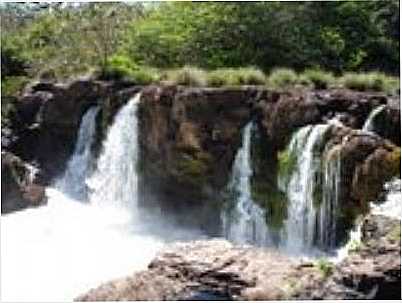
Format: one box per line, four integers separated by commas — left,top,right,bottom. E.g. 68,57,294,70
165,66,207,86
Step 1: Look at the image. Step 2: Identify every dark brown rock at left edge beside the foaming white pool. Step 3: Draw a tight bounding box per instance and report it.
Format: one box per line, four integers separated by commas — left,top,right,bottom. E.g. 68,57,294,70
1,152,46,214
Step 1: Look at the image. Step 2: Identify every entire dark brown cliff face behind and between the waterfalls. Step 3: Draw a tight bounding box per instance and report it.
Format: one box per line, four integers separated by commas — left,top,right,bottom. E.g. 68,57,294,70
2,79,400,221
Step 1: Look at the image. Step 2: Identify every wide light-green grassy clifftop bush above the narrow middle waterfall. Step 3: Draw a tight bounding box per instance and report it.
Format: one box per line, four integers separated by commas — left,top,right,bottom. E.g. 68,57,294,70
207,67,266,87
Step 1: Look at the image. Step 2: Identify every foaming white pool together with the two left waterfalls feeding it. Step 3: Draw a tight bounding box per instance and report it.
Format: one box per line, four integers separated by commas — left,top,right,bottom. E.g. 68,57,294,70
1,95,204,302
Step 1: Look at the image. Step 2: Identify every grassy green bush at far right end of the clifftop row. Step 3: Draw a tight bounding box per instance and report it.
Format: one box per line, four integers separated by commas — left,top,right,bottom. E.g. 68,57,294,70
341,72,399,92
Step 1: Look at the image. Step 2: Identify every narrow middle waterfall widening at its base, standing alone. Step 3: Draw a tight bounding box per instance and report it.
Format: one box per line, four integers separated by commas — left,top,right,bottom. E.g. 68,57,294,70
221,122,270,245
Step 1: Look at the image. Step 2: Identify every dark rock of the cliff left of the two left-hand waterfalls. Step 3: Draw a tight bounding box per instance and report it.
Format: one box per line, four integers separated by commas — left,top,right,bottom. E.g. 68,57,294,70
2,78,138,184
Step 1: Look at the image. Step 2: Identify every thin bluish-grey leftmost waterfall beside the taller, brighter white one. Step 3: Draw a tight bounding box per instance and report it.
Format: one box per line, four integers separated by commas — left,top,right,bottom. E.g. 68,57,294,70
55,106,99,200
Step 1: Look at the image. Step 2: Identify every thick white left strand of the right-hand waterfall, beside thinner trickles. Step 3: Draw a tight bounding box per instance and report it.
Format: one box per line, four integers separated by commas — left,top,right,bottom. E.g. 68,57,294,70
282,124,332,252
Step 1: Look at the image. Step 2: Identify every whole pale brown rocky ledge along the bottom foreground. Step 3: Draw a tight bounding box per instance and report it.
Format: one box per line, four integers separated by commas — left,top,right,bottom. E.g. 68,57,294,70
76,215,401,301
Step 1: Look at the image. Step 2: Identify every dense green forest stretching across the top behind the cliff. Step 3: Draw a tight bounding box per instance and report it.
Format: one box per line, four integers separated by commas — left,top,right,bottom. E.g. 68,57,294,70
0,0,399,102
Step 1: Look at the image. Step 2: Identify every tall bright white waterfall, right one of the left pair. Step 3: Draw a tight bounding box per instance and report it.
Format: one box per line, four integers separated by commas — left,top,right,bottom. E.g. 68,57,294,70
87,94,141,206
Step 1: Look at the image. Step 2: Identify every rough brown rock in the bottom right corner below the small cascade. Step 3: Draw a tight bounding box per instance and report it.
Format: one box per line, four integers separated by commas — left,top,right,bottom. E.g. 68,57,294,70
296,215,401,300
